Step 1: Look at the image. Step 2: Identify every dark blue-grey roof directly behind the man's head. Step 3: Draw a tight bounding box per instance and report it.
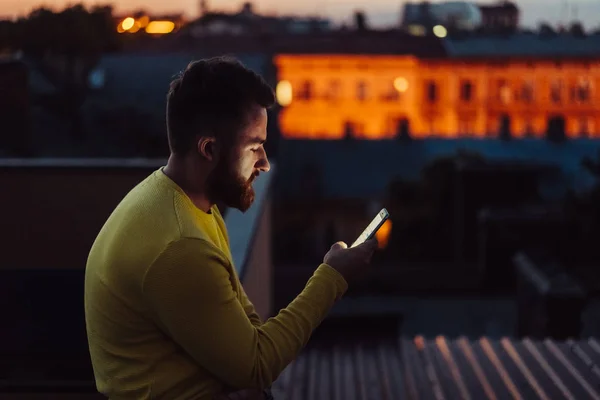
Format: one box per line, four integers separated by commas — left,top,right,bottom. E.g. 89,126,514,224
77,51,270,157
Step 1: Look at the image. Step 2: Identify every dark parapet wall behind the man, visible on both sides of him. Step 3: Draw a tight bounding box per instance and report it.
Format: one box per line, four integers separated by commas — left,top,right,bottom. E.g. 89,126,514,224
0,159,274,399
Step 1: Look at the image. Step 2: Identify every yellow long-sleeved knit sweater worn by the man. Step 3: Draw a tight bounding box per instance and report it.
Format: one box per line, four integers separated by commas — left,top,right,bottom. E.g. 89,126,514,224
85,170,347,400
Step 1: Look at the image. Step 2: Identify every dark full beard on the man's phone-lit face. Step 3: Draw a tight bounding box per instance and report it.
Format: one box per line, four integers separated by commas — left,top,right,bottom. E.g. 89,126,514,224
208,152,258,212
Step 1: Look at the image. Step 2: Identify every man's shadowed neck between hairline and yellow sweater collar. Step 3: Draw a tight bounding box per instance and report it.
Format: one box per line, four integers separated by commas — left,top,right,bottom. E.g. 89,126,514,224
163,154,213,212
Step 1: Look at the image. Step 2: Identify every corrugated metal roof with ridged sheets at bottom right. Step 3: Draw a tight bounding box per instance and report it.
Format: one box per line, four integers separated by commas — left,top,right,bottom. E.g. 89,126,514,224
273,336,600,400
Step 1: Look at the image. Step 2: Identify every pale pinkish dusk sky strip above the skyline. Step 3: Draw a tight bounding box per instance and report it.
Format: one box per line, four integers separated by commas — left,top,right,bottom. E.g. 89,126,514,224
0,0,600,28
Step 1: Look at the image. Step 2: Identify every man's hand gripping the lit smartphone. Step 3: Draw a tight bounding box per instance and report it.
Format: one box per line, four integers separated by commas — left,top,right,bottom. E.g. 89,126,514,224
323,239,377,284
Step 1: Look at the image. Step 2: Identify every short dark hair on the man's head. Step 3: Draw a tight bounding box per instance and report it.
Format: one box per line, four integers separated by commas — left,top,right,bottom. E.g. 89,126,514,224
167,57,275,155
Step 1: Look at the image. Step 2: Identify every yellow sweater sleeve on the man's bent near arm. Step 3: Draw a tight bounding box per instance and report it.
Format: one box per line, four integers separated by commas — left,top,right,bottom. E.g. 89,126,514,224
143,239,347,389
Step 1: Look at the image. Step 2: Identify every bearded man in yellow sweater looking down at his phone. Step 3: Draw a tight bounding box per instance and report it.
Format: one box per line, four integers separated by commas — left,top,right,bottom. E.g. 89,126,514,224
85,58,375,400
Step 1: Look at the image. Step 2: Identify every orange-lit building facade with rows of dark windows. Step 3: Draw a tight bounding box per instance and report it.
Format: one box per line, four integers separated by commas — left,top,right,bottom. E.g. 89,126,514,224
275,54,600,139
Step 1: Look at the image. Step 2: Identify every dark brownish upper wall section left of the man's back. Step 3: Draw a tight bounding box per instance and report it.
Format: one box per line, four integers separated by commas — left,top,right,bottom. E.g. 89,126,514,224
0,161,161,269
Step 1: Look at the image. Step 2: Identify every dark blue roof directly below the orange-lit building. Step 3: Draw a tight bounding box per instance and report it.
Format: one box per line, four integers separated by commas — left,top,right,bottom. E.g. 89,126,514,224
278,139,599,199
